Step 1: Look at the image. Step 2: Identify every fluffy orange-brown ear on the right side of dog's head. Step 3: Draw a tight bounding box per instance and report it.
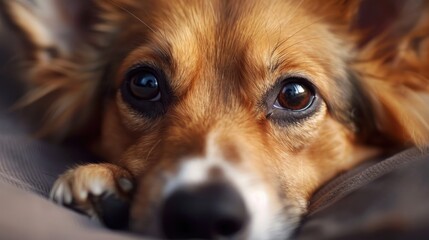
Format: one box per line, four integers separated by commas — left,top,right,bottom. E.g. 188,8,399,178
350,0,429,146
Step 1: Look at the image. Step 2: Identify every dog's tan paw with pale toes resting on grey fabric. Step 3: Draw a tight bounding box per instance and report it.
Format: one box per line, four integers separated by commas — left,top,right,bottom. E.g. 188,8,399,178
50,163,133,229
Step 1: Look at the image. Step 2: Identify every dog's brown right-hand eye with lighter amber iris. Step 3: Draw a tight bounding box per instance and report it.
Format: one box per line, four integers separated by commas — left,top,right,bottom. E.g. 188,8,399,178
275,82,314,111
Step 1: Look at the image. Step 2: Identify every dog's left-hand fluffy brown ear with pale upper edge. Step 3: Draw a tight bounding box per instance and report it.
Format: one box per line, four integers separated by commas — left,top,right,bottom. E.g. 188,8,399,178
0,0,120,137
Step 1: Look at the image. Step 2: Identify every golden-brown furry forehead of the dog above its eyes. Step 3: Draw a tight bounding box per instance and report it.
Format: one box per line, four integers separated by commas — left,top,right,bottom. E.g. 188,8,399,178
117,0,344,105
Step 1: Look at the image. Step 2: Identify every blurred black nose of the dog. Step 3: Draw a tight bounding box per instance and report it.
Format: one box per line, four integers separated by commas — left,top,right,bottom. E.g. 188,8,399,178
162,183,248,239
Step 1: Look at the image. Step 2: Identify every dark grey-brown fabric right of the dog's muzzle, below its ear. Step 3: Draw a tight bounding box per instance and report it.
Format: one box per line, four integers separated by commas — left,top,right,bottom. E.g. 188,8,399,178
298,148,429,240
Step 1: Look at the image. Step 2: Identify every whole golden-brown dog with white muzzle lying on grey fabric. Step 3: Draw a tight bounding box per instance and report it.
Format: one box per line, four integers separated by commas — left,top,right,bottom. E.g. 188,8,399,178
1,0,429,240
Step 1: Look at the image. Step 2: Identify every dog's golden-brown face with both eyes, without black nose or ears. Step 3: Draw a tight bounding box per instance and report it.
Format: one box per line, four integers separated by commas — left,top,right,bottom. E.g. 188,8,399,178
101,1,378,236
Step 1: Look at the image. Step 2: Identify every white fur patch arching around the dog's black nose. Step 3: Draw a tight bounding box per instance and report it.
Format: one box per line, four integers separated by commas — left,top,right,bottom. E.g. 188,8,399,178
163,134,295,240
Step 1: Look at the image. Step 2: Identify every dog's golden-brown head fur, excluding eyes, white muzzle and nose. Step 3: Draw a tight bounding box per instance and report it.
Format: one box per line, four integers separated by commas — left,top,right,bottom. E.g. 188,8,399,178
3,0,429,237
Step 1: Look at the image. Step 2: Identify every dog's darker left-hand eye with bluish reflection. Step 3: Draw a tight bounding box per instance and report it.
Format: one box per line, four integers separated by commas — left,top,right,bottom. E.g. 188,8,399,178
130,71,161,101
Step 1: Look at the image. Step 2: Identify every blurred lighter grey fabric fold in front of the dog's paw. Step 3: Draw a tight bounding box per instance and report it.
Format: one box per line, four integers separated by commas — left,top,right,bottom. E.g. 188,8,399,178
0,182,141,240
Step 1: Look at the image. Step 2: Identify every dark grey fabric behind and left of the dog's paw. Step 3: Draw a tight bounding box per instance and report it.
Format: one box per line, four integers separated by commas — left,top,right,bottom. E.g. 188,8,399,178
0,134,94,197
